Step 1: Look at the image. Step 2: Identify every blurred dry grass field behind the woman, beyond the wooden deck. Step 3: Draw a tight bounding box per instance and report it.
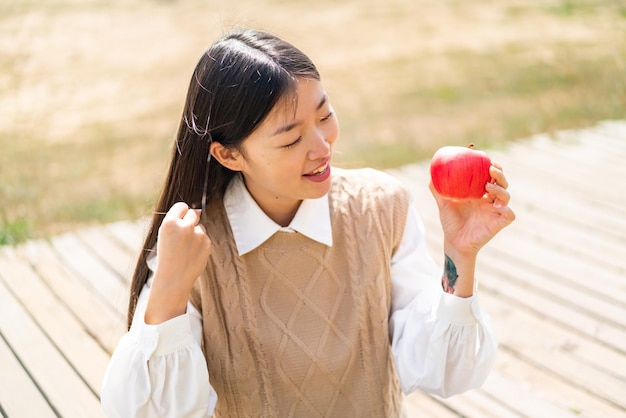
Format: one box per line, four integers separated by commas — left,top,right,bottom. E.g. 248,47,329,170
0,0,626,244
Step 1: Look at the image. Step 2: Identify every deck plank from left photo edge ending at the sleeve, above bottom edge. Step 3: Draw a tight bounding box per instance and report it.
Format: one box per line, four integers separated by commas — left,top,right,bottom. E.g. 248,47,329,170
0,248,109,394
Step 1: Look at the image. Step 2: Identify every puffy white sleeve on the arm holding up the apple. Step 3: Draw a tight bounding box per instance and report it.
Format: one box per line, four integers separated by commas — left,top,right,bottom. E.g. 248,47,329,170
389,206,498,397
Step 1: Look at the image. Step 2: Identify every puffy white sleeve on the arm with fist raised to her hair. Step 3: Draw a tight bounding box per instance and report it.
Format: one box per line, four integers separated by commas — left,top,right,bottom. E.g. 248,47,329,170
101,282,217,418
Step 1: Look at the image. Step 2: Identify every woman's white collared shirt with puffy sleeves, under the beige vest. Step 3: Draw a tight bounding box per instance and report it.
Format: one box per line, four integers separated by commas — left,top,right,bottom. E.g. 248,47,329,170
101,173,497,417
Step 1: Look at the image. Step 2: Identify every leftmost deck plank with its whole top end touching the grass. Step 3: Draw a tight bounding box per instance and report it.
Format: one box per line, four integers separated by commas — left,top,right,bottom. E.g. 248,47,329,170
16,240,126,353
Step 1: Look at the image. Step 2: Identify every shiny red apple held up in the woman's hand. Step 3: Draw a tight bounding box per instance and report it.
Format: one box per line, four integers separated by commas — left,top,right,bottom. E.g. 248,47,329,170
430,144,491,199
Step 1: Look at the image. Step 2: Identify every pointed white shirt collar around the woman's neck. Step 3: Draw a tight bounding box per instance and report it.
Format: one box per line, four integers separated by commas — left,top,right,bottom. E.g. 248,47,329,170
224,176,333,256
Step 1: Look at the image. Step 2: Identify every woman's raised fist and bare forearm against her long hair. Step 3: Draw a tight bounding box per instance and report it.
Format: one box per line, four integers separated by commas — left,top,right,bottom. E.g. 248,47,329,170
145,202,211,324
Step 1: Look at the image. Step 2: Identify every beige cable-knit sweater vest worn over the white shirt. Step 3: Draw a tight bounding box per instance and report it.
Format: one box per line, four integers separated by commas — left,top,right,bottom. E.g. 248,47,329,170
192,169,409,418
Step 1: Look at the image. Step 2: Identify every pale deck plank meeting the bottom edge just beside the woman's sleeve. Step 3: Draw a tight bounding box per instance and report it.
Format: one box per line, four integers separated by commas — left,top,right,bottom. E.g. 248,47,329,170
0,281,104,418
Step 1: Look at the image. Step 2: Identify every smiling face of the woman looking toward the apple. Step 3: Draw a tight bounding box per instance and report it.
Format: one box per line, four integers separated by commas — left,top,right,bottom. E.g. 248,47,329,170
238,79,339,226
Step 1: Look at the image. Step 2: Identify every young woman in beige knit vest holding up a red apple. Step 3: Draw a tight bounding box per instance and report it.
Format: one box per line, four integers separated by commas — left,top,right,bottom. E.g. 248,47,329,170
102,31,514,417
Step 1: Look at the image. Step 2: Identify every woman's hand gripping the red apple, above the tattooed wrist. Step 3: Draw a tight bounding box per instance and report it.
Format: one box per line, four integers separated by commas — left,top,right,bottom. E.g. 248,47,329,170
430,164,515,256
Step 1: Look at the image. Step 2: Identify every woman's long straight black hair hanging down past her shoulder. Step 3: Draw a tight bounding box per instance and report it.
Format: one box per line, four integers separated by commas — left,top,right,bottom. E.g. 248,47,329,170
127,30,320,328
